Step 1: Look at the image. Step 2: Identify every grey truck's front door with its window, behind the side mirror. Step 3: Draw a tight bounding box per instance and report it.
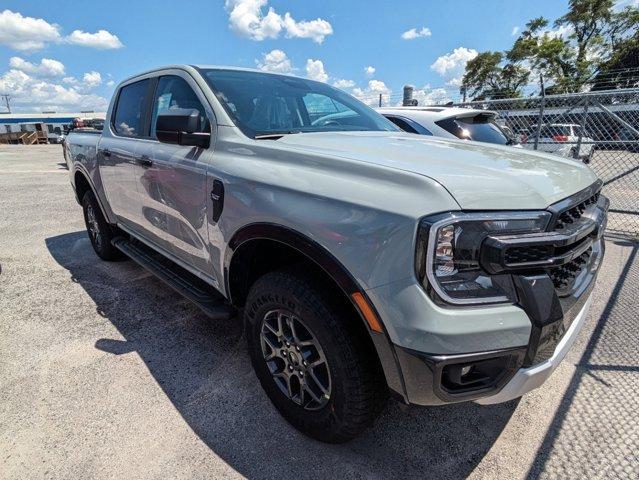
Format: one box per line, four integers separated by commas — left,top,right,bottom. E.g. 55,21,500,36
138,71,214,276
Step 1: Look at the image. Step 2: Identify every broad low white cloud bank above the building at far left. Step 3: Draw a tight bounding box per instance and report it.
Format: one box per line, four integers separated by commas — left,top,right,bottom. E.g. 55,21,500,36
0,69,108,111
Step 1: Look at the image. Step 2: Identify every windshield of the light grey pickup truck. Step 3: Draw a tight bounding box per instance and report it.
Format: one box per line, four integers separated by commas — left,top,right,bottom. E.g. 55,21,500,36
200,69,398,138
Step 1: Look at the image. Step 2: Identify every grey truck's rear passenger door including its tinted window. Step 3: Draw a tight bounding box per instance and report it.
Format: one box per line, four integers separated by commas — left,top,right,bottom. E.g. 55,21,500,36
98,79,151,230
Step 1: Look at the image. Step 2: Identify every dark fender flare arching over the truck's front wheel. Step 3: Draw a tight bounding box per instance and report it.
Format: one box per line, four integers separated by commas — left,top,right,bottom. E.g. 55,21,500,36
224,223,408,403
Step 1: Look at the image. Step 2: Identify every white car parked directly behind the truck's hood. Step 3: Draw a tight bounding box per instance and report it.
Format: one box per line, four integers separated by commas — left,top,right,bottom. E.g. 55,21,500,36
377,107,517,145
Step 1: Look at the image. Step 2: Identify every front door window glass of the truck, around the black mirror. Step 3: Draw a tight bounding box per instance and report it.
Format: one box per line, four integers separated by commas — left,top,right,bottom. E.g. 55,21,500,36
151,75,210,138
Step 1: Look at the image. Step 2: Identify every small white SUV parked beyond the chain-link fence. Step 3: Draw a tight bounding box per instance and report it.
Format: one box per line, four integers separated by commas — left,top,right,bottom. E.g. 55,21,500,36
523,123,595,163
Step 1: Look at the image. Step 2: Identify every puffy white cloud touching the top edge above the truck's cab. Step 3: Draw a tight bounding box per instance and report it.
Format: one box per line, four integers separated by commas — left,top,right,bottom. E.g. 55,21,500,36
225,0,333,43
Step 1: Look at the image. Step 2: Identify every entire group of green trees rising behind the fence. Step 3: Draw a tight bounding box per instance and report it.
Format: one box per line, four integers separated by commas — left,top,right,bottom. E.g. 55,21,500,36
464,0,639,98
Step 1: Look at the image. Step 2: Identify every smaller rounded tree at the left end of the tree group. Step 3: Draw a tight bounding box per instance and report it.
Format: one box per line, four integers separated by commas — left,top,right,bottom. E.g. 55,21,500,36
463,52,530,100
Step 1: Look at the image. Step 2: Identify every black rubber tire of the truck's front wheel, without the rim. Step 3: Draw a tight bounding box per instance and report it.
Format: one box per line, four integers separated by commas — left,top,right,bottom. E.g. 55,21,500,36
244,270,388,443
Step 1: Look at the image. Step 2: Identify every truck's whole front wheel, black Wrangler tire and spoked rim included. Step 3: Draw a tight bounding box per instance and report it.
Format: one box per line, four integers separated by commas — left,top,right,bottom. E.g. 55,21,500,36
244,271,387,443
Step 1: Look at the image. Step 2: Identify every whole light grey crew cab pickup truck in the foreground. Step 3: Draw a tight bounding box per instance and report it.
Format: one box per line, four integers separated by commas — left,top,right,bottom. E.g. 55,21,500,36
65,66,608,442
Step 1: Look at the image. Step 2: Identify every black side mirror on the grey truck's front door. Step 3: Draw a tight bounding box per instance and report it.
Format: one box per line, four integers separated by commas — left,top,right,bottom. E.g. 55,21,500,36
155,108,211,148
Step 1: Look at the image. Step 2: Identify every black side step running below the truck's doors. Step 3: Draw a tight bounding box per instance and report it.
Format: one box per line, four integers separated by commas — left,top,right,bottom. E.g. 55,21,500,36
111,237,235,320
